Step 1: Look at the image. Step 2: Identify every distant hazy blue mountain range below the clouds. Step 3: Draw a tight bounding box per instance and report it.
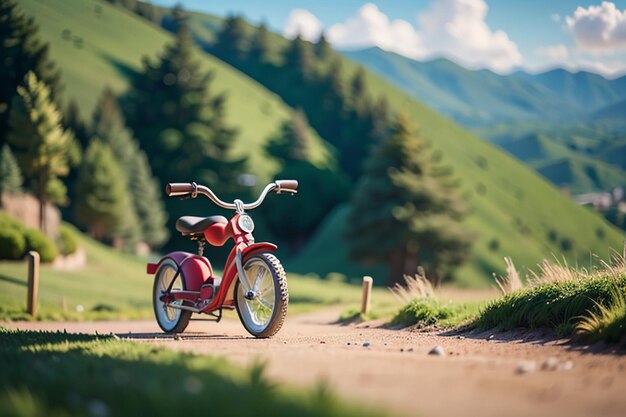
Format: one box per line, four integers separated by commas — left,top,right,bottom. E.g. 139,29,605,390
343,47,626,127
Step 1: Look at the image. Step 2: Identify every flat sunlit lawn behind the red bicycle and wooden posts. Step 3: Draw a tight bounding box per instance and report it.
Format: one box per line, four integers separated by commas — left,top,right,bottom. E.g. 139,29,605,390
0,224,393,320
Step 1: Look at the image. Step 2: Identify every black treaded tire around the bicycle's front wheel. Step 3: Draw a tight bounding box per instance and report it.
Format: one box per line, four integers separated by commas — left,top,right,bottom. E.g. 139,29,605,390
234,253,289,338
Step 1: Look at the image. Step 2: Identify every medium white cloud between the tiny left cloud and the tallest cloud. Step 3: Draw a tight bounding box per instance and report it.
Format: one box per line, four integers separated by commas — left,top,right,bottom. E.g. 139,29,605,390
326,3,425,58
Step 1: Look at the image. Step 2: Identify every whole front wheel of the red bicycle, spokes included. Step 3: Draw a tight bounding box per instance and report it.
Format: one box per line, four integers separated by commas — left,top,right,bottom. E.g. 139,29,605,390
235,253,289,338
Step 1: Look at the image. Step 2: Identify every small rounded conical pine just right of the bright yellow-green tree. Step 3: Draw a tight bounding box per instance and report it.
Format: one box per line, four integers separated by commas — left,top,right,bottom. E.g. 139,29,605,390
75,139,131,240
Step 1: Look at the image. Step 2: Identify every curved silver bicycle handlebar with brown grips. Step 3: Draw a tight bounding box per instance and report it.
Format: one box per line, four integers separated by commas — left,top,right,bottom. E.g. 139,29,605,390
165,180,298,210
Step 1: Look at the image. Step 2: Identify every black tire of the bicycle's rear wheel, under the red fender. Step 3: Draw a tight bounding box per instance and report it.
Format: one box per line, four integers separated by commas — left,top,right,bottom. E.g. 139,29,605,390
152,259,192,334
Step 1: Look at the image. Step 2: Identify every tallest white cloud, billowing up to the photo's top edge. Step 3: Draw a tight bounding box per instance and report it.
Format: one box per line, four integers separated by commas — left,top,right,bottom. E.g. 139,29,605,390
419,0,523,72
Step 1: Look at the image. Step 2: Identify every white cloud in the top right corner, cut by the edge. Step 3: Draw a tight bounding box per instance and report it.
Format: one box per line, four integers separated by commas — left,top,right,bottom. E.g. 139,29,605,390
565,1,626,52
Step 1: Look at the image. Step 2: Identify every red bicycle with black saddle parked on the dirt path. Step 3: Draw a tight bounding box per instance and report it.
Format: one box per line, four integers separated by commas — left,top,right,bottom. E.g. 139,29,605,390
148,180,298,338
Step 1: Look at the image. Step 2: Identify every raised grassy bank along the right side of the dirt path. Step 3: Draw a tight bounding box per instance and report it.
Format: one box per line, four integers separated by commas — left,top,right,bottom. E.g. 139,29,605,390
472,274,626,339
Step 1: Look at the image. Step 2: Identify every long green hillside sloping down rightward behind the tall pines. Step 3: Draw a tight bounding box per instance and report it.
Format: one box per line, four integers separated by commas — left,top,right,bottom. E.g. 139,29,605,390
177,13,623,285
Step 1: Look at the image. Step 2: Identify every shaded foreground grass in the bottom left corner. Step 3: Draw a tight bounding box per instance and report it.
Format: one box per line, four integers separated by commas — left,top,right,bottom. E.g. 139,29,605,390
0,328,380,417
